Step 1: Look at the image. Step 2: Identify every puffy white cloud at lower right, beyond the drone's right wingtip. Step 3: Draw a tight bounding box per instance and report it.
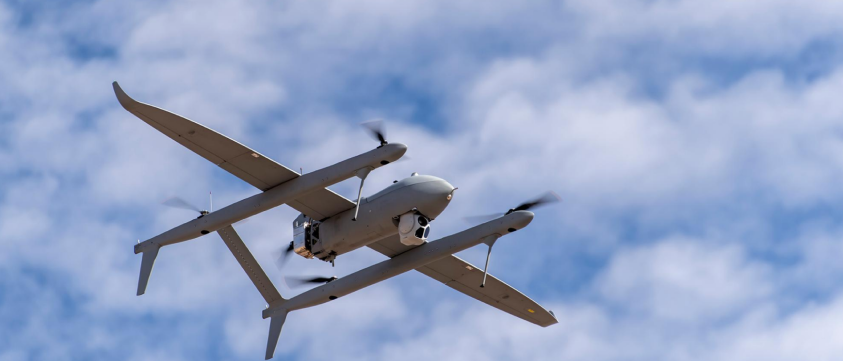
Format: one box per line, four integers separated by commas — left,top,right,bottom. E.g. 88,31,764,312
596,239,773,325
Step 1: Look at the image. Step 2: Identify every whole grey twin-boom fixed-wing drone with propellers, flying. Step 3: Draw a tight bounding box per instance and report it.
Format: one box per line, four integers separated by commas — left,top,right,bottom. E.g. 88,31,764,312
113,82,557,360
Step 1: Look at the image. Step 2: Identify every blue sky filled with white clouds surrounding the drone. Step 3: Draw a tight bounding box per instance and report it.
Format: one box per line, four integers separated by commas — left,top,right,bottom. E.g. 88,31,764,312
0,0,843,361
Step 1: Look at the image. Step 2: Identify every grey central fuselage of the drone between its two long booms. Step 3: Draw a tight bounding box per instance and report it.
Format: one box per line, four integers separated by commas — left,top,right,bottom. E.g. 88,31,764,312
294,175,455,261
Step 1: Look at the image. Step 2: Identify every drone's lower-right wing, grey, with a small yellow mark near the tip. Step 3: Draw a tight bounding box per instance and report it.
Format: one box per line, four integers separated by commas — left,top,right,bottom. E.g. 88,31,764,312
369,236,557,327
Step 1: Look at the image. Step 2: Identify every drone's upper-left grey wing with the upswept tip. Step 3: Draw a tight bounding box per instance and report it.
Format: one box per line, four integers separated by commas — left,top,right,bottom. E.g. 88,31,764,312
113,82,354,219
